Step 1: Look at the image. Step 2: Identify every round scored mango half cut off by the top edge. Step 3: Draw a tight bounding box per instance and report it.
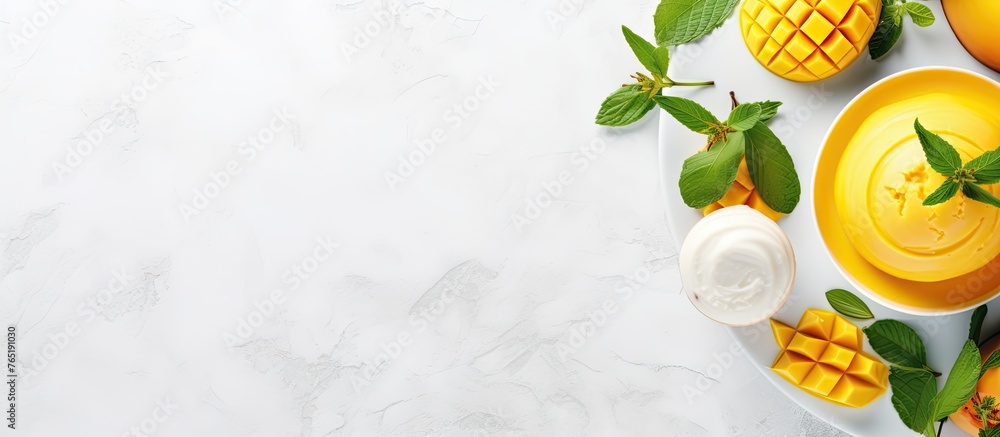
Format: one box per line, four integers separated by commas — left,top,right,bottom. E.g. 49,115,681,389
740,0,882,82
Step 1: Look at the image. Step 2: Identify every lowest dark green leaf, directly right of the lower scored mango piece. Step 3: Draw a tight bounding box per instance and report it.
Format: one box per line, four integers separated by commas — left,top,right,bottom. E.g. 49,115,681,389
889,366,937,433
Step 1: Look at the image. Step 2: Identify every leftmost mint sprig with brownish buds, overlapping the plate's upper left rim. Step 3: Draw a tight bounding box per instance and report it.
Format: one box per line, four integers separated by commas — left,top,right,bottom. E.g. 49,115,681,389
595,26,715,126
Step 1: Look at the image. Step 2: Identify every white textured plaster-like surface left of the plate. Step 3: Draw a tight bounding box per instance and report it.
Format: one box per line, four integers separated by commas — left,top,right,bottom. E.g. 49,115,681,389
0,0,852,436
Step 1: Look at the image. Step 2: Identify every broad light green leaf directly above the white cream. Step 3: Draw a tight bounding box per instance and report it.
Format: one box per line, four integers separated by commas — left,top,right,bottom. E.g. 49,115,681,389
679,132,743,209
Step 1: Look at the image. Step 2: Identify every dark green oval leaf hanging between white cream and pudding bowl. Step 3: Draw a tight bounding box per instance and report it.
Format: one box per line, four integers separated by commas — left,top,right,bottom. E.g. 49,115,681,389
743,122,802,214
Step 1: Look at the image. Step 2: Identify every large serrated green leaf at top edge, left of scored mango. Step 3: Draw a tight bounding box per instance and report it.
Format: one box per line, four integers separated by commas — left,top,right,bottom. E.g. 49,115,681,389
653,0,739,46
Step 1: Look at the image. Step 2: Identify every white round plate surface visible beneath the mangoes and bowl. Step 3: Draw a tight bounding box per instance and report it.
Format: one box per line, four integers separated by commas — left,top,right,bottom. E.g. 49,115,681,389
659,2,1000,437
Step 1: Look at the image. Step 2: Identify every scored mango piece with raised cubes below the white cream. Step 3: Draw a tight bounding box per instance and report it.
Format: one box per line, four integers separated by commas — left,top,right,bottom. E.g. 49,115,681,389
771,309,889,408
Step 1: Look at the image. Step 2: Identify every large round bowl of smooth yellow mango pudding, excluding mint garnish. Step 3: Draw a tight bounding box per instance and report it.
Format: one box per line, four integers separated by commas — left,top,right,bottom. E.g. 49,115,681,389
812,67,1000,315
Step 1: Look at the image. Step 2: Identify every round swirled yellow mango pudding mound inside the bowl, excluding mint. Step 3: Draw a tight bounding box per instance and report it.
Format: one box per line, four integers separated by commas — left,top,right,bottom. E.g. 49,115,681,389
833,94,1000,282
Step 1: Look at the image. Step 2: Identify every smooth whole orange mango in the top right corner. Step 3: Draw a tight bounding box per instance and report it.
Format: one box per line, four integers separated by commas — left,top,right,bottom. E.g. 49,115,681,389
941,0,1000,71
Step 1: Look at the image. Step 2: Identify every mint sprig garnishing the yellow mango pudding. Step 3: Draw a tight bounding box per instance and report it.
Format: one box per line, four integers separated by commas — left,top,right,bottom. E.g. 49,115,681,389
913,119,1000,208
